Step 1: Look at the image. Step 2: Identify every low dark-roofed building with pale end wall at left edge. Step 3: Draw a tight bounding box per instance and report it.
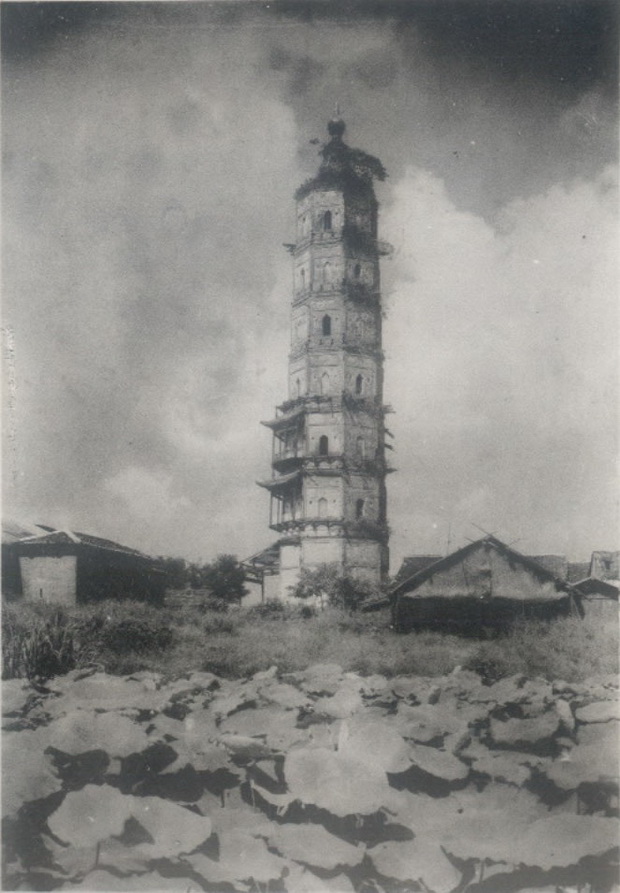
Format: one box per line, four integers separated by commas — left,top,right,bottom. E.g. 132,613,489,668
2,525,167,605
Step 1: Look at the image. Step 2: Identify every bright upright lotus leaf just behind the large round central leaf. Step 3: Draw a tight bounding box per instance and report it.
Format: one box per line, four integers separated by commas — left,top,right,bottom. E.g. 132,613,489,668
338,717,411,772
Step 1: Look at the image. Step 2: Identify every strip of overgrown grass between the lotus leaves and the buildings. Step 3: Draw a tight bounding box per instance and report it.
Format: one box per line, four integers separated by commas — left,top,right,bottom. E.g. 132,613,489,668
3,601,618,682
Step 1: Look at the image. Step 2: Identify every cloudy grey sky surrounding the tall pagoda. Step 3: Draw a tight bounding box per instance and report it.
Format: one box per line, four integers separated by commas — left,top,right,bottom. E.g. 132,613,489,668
2,0,618,572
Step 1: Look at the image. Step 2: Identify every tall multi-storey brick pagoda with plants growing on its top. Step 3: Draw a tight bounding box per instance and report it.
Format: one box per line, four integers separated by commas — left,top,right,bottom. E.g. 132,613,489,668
260,117,390,598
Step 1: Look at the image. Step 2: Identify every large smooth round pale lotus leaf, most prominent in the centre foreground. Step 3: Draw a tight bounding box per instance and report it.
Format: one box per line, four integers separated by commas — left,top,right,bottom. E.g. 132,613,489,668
284,747,395,816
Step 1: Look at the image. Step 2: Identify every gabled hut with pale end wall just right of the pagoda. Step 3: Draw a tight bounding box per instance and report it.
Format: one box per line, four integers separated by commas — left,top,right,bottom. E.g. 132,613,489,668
392,536,582,635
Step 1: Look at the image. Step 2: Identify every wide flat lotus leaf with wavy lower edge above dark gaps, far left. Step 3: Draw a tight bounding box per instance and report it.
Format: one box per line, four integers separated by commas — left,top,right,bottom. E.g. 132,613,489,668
46,710,150,757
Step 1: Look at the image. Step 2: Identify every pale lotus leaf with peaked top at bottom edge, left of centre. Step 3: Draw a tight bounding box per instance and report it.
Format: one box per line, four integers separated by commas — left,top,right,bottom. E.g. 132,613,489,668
186,831,286,884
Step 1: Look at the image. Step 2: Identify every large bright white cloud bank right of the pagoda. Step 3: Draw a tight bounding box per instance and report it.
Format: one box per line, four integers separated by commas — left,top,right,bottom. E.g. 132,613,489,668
382,168,617,555
